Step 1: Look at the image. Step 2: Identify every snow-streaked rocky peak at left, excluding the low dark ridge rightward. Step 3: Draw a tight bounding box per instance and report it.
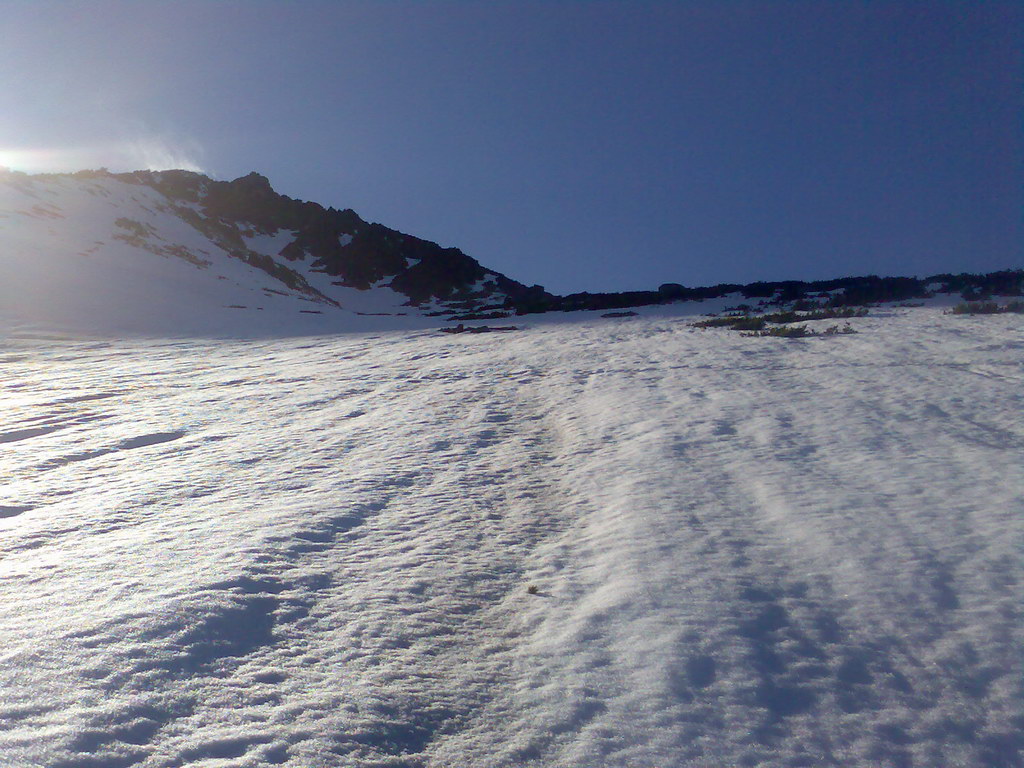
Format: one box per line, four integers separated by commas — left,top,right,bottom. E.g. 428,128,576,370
0,170,546,330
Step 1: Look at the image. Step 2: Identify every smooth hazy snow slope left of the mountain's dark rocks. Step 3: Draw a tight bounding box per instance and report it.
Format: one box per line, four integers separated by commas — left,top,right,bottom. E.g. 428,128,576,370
0,177,350,335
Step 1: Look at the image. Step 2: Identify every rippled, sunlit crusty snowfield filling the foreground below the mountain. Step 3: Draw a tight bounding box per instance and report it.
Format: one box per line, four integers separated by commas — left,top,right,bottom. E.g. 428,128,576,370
0,308,1024,768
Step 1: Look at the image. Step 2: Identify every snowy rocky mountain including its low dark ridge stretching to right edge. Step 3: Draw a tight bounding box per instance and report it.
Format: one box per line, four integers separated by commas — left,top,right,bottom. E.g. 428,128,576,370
0,170,1024,336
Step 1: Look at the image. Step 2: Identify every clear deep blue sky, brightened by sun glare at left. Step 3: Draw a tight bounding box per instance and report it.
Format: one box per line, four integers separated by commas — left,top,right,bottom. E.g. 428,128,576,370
0,0,1024,293
